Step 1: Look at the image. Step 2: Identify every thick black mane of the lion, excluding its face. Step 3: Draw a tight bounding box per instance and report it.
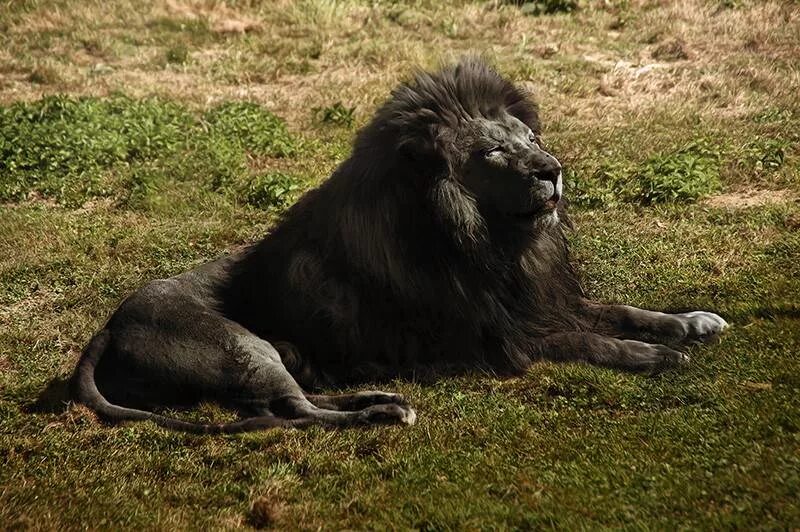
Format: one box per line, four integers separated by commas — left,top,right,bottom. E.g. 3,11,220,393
220,58,583,385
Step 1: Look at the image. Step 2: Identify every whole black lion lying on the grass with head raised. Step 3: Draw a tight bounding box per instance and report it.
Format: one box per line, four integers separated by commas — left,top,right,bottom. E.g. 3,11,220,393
72,58,726,432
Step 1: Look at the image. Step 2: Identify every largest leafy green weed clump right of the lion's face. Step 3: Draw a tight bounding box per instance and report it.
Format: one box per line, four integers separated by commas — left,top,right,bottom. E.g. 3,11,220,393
633,142,721,204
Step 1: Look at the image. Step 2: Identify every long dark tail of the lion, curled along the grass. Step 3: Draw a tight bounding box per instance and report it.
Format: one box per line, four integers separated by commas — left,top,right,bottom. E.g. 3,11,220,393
71,329,292,434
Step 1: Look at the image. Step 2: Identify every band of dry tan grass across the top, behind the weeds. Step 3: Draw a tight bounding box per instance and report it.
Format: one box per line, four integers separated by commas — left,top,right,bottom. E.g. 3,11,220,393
0,0,800,128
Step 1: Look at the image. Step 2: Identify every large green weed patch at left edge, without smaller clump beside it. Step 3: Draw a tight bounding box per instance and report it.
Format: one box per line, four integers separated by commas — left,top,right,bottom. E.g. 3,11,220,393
0,96,193,204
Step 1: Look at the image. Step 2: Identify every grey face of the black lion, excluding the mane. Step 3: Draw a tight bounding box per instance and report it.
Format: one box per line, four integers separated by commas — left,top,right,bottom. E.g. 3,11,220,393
453,113,563,221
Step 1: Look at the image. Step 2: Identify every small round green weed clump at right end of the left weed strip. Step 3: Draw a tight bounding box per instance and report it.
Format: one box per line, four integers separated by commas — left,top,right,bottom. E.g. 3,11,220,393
203,102,297,157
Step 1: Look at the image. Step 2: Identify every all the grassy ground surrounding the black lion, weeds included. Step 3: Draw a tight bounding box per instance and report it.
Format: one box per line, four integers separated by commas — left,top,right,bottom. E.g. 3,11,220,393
0,0,800,529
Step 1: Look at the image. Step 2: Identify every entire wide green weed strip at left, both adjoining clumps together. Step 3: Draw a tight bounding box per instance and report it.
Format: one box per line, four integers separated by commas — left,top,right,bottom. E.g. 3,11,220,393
0,96,296,206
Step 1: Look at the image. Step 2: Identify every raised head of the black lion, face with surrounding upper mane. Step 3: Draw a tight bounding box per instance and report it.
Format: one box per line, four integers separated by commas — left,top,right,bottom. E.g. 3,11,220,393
356,57,563,240
